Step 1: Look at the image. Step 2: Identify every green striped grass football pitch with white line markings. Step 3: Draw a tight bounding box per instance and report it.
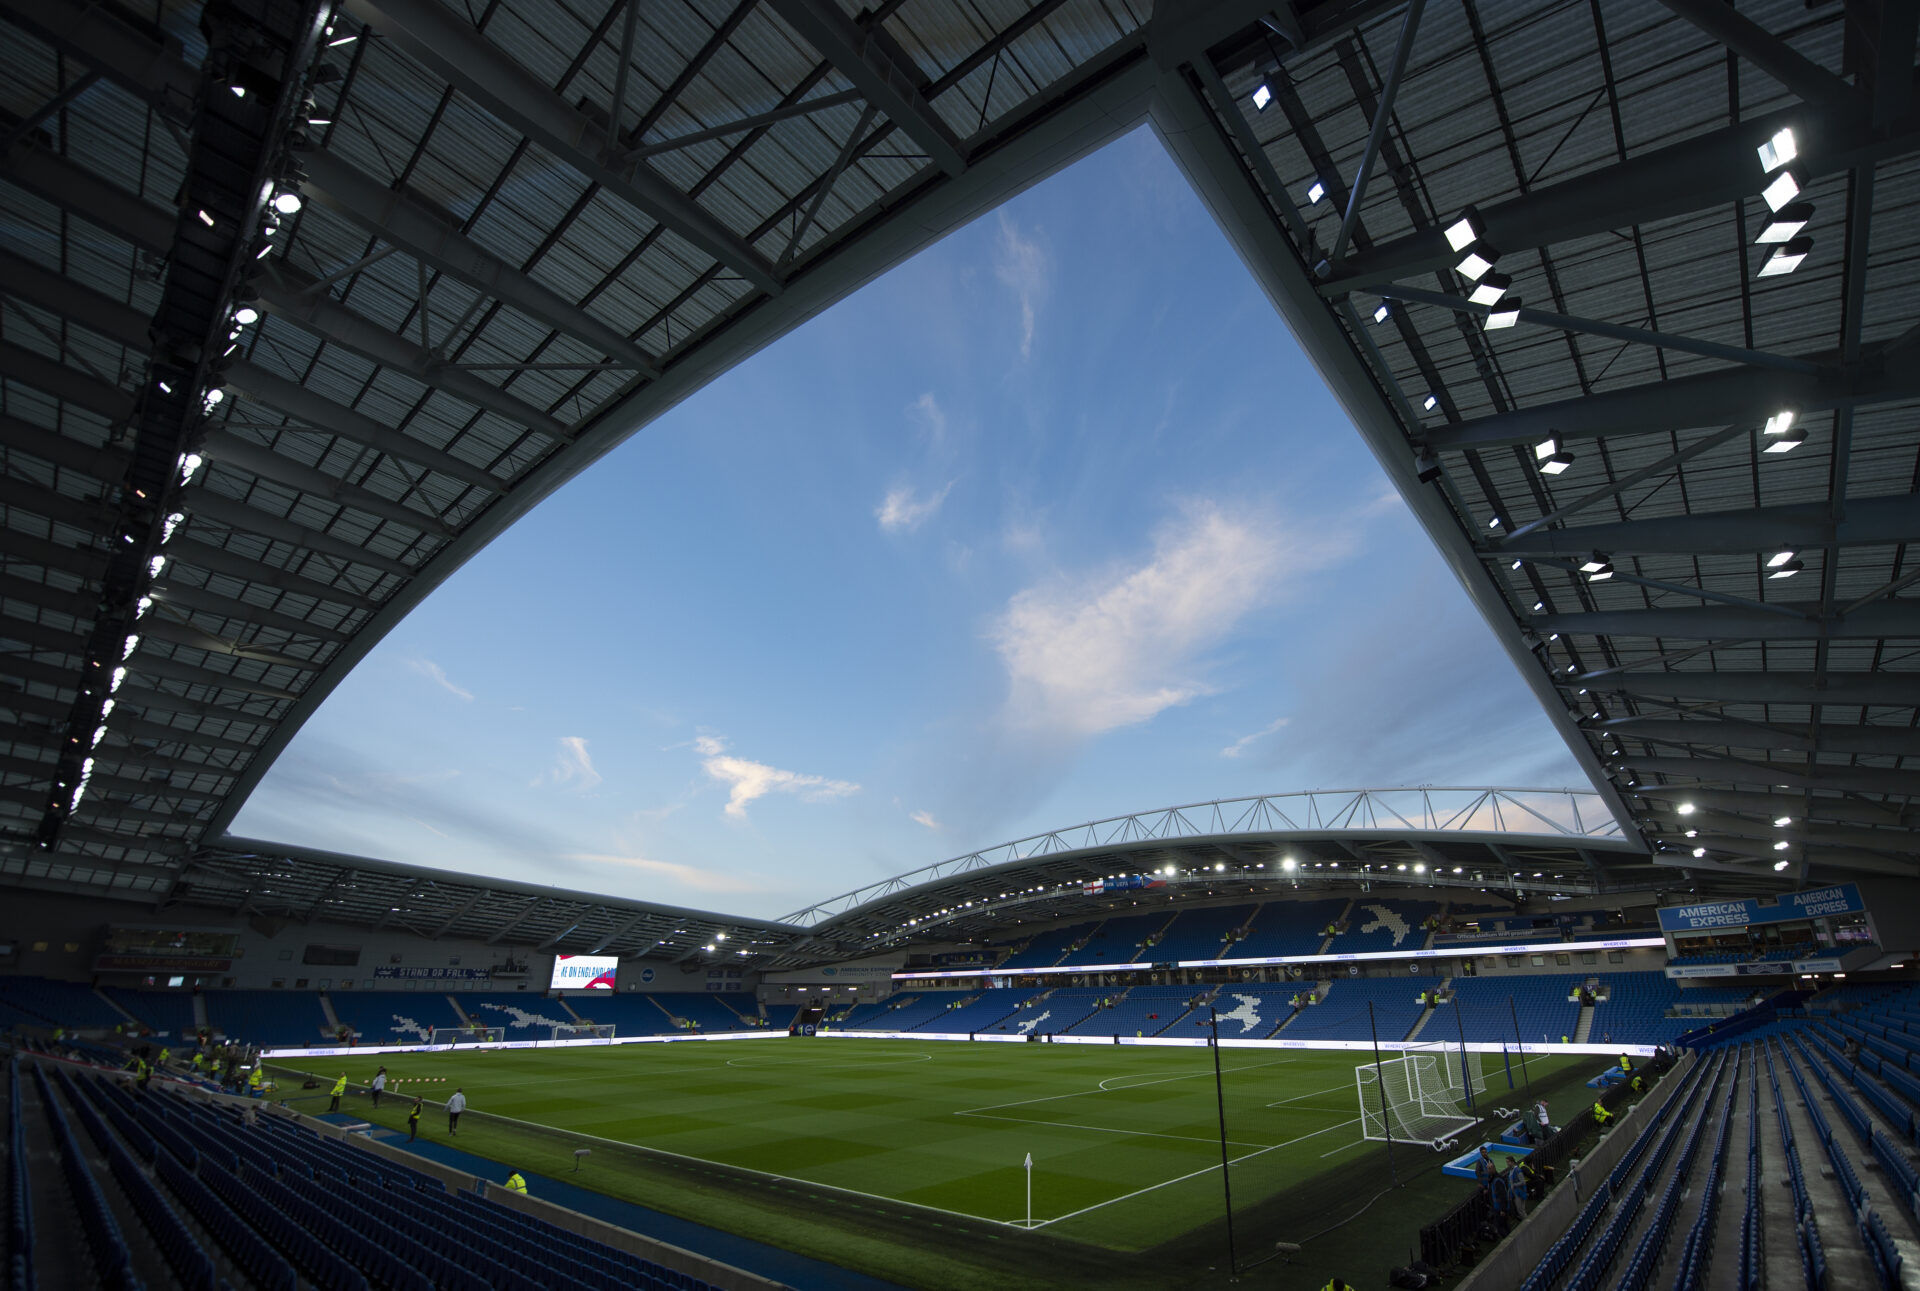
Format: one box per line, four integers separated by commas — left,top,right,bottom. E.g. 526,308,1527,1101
270,1037,1592,1272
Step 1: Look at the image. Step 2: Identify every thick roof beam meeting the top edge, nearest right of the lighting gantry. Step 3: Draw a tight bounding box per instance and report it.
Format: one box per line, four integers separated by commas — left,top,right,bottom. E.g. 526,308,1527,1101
346,0,780,296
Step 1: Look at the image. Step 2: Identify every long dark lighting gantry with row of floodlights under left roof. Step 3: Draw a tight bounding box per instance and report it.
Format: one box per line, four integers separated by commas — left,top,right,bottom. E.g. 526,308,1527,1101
35,0,332,851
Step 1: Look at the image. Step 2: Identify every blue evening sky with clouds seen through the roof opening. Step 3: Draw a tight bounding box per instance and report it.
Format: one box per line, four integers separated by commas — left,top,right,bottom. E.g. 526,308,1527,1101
234,131,1586,916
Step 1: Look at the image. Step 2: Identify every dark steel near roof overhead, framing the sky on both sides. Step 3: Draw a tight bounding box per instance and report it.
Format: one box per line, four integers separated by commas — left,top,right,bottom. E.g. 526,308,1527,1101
0,0,1920,914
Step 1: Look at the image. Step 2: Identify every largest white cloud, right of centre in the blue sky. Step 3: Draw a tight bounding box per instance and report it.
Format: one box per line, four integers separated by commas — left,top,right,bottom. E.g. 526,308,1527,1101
991,505,1338,738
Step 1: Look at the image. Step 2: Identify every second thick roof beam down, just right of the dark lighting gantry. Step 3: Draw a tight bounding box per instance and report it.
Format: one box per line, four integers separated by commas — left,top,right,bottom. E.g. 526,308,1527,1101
300,149,659,377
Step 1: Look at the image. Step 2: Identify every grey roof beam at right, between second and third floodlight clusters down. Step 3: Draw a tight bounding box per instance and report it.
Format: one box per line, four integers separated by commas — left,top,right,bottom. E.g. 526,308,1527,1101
1480,494,1920,559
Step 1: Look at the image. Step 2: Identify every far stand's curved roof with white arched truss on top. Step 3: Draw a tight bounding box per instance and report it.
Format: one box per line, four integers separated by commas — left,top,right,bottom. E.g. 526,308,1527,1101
776,788,1651,962
